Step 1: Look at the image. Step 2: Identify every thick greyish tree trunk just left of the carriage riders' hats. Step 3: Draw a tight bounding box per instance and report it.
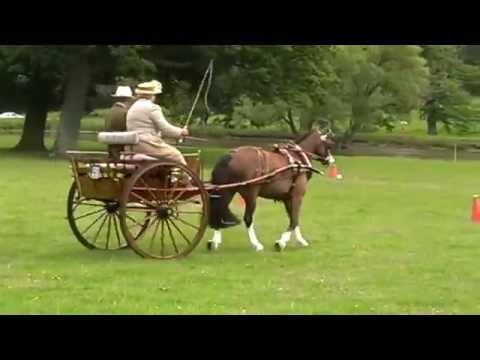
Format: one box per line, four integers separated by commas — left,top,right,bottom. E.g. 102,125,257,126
55,53,90,154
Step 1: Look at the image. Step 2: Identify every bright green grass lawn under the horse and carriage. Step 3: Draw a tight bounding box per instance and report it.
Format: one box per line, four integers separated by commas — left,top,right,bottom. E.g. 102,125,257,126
0,136,480,314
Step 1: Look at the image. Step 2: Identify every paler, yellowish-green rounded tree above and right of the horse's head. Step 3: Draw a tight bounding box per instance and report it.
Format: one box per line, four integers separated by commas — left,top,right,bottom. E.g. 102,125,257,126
325,45,429,142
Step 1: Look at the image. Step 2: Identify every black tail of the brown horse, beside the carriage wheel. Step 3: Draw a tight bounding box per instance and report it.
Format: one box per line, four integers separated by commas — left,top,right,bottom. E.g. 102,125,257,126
210,155,240,230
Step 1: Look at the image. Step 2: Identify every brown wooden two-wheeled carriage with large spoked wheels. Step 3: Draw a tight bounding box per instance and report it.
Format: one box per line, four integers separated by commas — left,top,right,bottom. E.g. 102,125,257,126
67,131,209,260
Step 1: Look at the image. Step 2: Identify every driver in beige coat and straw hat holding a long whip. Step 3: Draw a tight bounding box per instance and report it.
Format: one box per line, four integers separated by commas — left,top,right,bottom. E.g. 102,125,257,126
127,81,189,165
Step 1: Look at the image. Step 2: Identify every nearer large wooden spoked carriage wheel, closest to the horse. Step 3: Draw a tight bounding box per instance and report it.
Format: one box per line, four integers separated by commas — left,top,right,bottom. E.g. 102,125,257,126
120,163,209,260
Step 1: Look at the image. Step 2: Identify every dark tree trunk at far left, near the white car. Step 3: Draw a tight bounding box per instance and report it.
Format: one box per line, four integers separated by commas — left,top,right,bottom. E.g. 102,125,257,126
14,88,49,152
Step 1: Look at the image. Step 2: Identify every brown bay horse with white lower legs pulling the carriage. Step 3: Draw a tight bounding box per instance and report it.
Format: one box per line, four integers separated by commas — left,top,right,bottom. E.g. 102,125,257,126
208,129,335,251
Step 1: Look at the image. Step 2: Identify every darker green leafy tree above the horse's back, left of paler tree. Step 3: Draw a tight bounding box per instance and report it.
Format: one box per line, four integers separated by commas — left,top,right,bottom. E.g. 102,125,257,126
206,45,333,133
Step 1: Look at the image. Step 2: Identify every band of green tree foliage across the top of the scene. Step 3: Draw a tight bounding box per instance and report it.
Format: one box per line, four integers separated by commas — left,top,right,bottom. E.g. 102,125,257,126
0,45,480,148
